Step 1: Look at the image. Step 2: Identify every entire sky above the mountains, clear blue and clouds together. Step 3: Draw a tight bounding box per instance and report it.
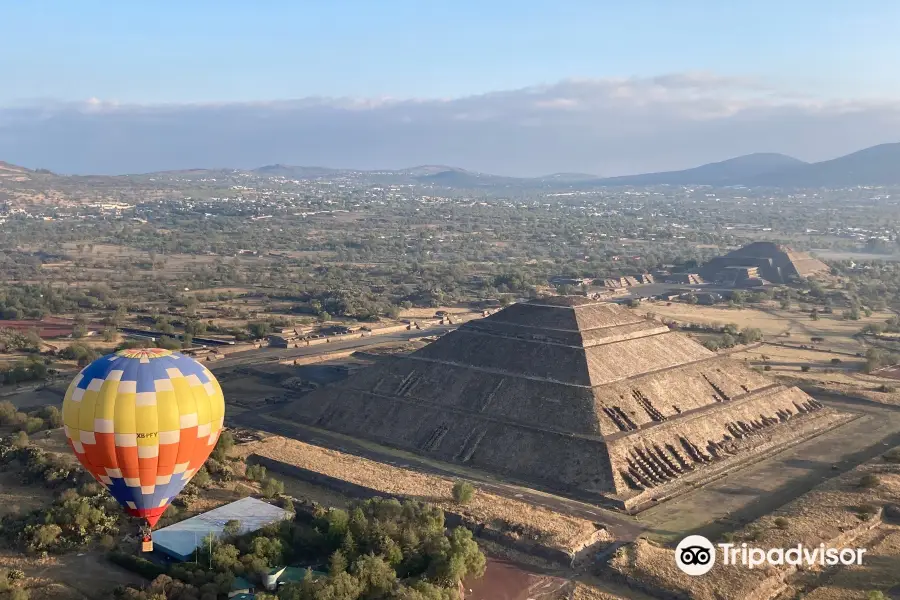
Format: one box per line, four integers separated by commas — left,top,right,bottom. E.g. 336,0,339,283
0,0,900,175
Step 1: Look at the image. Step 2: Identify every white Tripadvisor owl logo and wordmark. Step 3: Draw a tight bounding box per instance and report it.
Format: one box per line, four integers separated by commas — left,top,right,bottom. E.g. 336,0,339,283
675,535,866,575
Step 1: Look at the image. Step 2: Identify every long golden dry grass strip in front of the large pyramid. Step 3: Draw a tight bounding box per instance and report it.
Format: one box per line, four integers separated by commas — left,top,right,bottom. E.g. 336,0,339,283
238,436,598,552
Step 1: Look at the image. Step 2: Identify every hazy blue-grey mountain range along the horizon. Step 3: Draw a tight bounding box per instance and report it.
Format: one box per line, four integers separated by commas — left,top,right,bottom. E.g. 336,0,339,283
0,143,900,189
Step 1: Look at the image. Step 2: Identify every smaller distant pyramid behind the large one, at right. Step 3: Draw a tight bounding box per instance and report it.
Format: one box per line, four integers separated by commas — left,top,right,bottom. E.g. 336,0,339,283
700,242,829,283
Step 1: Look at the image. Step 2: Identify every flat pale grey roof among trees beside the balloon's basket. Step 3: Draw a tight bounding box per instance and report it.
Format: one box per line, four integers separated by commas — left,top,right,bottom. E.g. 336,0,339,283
153,498,294,562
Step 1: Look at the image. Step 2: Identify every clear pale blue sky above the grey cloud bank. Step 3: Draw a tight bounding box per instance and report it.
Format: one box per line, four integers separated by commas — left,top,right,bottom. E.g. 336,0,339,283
0,0,900,105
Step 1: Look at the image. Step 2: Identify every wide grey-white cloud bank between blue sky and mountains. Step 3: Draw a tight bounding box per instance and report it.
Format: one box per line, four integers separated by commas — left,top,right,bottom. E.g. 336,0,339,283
0,73,900,175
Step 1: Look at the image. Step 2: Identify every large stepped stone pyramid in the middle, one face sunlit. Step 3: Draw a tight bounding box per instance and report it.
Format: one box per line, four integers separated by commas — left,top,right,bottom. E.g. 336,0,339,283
281,296,822,497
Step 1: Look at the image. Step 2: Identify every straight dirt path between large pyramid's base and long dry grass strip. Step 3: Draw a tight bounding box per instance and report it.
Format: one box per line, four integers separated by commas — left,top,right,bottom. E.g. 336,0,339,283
233,407,644,541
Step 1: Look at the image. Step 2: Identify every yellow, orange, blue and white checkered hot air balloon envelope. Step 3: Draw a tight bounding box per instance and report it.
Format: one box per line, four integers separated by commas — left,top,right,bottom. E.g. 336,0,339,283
63,348,225,527
